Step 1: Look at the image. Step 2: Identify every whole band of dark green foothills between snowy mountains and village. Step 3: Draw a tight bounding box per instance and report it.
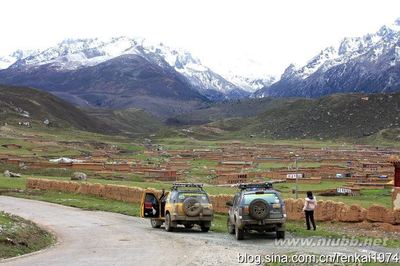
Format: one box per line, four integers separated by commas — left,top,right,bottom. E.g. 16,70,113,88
0,86,400,141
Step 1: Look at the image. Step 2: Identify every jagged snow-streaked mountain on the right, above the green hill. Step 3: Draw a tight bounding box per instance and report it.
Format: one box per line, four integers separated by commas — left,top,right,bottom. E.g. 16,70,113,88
255,18,400,97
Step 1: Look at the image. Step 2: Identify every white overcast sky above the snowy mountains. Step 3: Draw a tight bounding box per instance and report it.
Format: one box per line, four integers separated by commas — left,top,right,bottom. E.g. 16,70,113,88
0,0,400,75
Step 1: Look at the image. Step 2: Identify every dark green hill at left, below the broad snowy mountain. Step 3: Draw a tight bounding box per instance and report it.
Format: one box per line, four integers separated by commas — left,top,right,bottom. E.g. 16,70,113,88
0,85,168,136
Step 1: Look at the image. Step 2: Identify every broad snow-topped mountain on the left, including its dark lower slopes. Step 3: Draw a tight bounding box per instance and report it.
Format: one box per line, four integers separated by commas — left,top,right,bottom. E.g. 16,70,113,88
0,37,272,113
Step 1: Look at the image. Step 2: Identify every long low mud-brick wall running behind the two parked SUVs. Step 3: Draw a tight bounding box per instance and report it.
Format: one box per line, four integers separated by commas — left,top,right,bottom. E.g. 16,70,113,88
26,178,400,225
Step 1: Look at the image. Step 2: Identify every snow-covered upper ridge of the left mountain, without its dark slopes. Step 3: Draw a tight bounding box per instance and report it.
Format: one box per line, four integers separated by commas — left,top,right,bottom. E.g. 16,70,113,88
1,37,250,100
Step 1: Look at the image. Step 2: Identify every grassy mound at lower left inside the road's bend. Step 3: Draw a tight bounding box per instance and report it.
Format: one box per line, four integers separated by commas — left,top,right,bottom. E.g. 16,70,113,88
0,212,55,259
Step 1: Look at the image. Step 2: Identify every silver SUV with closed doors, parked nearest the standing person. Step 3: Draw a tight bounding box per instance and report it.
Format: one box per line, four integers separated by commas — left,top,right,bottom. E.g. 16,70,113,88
226,183,286,240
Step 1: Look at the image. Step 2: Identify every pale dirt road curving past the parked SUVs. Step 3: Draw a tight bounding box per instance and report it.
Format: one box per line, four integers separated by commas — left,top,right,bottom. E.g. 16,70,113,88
0,196,396,265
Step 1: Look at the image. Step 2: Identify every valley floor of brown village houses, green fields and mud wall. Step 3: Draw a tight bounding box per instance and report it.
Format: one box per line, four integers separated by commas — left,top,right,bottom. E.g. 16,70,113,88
0,119,400,264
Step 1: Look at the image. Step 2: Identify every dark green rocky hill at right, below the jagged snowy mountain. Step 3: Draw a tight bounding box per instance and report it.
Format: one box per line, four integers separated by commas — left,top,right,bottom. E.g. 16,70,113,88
186,93,400,141
